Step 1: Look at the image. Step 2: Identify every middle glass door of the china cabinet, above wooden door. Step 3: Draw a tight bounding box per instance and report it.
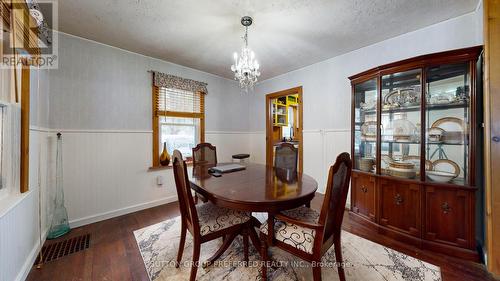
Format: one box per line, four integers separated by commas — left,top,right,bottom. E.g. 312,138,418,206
380,69,422,179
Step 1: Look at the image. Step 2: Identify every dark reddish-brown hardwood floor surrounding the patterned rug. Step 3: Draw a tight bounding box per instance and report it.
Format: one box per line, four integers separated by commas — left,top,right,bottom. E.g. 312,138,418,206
27,194,494,281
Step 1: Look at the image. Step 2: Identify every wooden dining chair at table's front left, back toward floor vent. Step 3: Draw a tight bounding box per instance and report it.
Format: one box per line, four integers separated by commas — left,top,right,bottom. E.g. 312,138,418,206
173,150,252,281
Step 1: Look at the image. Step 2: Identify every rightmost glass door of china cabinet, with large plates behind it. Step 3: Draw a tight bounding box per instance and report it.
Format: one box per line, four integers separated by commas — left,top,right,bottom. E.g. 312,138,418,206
425,63,470,185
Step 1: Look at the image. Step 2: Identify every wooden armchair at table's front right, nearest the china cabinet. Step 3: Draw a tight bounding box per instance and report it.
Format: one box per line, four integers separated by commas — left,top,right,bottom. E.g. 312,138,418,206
260,152,352,281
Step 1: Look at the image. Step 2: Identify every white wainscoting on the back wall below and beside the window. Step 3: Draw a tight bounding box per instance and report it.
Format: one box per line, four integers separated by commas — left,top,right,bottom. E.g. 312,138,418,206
52,130,258,227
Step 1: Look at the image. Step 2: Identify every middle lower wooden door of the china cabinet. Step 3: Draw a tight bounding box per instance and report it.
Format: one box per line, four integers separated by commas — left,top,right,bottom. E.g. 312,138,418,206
379,179,422,237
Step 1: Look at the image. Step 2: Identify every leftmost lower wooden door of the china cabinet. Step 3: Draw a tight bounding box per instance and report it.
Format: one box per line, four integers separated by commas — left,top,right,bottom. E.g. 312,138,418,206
351,172,376,221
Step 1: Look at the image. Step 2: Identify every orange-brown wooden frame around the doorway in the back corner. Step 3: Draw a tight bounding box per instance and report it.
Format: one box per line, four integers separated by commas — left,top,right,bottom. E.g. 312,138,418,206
266,86,304,173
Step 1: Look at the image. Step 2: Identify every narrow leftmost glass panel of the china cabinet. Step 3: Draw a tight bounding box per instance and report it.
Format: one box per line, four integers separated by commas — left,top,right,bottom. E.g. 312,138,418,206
354,78,378,173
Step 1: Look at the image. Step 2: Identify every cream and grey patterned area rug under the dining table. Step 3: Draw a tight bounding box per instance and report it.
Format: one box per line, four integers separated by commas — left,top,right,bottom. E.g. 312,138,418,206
134,217,441,281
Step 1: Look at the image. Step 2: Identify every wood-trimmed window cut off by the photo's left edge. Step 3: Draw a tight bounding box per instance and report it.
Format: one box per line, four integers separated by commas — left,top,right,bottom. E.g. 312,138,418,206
0,0,33,194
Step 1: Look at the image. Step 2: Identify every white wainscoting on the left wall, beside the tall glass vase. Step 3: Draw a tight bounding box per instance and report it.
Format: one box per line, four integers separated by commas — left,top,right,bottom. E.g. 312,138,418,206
0,129,55,281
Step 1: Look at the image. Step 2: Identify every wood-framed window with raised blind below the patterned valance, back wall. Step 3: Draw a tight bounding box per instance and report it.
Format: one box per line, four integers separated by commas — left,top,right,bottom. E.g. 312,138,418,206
153,86,205,167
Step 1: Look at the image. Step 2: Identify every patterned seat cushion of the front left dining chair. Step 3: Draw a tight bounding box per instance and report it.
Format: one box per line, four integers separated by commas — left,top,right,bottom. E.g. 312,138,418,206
196,203,252,236
